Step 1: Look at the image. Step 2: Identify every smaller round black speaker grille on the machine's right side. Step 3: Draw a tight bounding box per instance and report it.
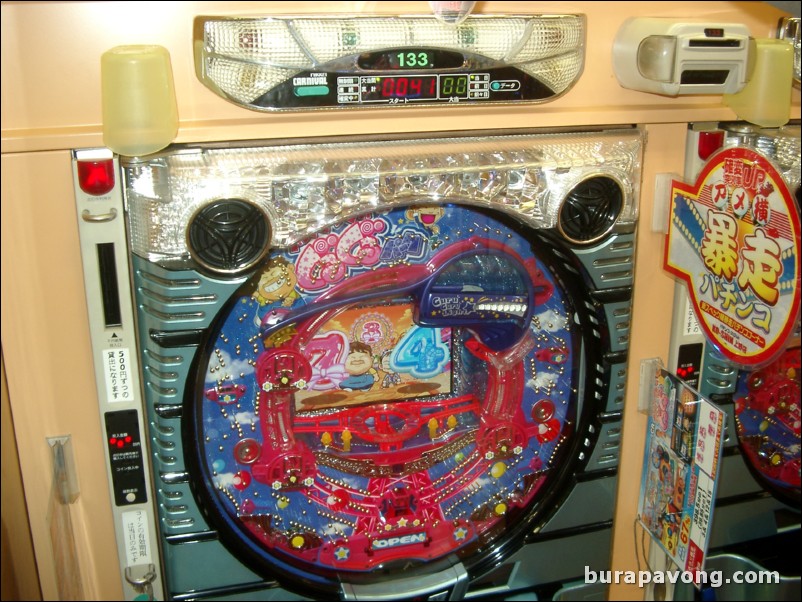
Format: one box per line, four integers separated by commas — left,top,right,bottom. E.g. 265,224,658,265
559,176,624,244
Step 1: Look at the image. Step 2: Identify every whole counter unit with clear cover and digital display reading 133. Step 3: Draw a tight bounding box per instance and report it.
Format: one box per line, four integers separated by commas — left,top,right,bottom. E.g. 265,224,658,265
195,15,585,111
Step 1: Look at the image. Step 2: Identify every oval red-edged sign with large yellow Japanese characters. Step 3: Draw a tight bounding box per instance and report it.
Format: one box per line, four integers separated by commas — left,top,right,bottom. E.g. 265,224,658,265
664,148,800,368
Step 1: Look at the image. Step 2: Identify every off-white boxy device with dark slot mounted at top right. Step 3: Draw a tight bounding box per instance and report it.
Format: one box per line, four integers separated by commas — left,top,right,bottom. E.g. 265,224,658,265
613,17,754,96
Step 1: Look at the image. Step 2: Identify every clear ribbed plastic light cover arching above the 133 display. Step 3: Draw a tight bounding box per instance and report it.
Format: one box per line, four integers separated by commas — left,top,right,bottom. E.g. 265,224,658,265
196,15,585,108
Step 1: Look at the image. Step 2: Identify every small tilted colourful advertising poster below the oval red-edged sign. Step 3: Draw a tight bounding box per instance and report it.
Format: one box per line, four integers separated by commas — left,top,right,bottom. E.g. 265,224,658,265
638,369,724,571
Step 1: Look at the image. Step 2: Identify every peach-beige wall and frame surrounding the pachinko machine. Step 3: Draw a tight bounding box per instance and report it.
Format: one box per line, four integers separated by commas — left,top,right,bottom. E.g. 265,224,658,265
0,2,799,600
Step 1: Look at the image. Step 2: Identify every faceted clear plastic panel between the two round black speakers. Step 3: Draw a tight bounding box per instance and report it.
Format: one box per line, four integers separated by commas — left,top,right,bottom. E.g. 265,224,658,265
126,130,642,260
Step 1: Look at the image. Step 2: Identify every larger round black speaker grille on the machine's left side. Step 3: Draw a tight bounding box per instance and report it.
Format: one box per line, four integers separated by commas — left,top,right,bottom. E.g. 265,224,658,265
187,199,270,274
